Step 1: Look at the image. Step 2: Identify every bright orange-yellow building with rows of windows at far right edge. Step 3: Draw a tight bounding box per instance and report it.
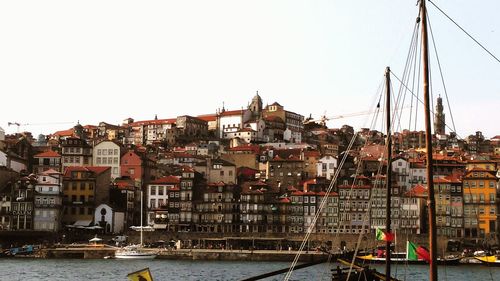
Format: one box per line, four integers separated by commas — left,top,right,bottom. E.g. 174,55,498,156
463,167,497,238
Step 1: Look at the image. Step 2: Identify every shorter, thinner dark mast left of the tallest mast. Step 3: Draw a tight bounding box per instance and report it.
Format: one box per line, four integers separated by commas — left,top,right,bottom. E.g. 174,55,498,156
385,67,392,280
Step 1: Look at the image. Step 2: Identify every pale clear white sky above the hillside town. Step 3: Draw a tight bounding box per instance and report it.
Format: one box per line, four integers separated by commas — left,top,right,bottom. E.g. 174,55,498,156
0,0,500,137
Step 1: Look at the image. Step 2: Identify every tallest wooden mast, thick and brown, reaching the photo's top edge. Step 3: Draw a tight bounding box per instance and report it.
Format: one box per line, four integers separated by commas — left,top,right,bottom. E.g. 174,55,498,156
420,0,438,281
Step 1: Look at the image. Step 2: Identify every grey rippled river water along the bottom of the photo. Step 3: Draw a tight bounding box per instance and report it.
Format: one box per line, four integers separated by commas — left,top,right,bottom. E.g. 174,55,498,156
0,258,500,281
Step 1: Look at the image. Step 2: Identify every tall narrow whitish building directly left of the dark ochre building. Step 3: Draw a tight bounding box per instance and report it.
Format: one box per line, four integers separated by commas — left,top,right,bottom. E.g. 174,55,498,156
33,170,63,232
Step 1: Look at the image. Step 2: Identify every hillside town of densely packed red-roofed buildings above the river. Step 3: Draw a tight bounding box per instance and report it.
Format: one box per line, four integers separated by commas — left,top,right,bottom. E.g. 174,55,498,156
0,93,500,244
